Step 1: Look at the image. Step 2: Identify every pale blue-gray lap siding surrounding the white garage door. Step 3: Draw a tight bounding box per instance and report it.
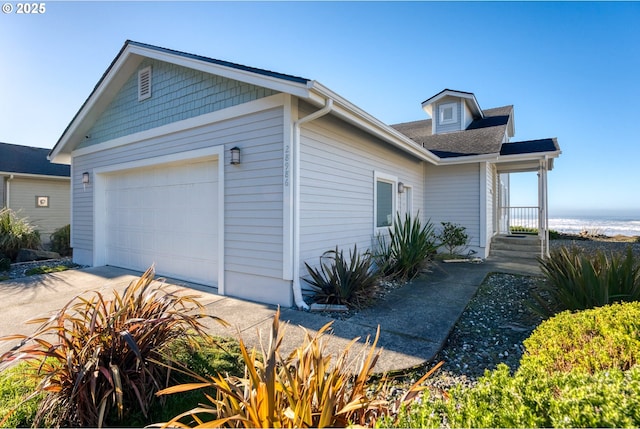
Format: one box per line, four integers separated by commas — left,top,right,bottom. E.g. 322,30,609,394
72,108,283,278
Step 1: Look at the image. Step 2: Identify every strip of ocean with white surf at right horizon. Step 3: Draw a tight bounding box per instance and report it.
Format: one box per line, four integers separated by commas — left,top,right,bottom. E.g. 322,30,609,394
549,213,640,237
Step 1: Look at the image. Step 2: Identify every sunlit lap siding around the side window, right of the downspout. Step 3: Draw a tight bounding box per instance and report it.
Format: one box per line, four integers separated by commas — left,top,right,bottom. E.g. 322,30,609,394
300,112,423,277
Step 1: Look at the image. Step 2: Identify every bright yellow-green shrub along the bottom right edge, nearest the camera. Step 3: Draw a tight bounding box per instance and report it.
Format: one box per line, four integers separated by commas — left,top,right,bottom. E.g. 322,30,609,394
388,364,640,428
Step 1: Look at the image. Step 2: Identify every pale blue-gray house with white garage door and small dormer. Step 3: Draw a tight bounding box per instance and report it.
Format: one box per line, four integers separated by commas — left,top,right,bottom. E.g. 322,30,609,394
49,41,560,307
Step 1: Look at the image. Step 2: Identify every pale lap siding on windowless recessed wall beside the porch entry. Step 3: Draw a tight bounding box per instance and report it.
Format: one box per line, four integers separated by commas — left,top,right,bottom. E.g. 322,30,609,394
424,164,480,246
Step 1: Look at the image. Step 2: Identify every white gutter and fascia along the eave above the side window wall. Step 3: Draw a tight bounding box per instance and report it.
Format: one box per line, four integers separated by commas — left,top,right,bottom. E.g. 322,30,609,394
309,81,439,164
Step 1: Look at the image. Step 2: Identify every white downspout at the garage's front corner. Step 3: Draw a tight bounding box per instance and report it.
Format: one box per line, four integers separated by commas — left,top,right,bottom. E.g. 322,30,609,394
292,98,333,310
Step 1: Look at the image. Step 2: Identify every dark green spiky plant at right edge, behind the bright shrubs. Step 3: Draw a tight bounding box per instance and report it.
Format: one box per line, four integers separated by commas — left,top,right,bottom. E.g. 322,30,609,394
538,247,640,314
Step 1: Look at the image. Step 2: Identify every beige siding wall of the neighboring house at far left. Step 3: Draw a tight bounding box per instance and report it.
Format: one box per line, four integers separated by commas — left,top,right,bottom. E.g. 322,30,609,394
9,177,70,245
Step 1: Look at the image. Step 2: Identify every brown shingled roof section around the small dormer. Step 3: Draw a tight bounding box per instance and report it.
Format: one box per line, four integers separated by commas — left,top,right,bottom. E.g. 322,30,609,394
392,106,513,158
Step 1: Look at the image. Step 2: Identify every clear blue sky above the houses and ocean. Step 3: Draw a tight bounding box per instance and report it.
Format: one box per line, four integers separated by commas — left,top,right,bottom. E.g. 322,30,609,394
0,1,640,218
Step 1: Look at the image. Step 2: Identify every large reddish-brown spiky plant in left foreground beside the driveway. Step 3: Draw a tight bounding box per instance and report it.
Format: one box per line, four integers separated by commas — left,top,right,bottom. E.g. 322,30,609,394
0,267,222,427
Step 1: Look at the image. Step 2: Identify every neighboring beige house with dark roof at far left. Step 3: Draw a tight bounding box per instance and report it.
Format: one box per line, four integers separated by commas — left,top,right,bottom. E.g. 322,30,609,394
0,143,70,246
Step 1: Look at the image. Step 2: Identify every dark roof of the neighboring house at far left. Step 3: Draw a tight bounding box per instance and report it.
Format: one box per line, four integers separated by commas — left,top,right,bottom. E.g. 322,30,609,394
0,143,71,177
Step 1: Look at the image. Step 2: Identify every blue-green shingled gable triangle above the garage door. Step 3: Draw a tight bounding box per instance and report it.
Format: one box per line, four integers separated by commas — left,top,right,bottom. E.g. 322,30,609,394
78,59,277,148
